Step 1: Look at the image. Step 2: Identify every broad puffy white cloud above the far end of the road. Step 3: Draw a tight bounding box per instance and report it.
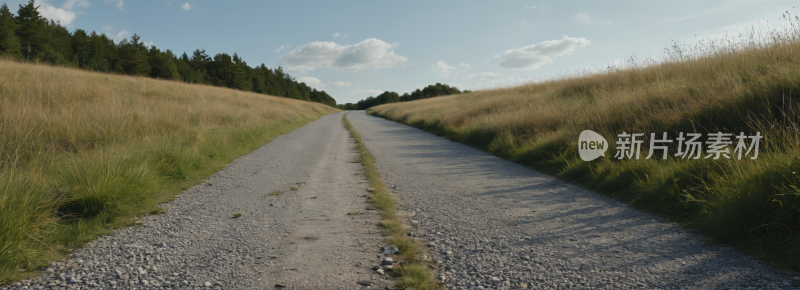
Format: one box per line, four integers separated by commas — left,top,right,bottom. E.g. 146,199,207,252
281,38,408,73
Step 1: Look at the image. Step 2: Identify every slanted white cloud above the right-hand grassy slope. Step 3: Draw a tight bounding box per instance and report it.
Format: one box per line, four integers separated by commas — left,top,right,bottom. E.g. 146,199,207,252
494,35,591,70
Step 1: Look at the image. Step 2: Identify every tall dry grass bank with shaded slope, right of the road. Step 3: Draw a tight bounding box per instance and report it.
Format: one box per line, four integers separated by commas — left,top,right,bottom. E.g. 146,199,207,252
371,22,800,270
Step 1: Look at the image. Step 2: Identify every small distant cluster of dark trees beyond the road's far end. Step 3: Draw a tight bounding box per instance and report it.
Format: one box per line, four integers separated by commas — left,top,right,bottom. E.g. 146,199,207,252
338,83,472,110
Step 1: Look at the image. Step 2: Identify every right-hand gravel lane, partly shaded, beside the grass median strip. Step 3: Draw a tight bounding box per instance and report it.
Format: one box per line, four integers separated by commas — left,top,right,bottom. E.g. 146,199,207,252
347,112,800,289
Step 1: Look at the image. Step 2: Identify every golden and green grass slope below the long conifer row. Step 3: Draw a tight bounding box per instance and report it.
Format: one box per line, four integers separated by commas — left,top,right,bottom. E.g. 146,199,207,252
0,61,338,284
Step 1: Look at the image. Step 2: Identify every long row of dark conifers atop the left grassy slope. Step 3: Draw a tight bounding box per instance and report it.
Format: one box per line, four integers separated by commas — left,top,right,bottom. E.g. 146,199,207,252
0,0,336,107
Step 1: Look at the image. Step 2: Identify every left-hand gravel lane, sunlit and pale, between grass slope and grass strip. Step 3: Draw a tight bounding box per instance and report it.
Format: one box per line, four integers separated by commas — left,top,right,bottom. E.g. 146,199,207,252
0,113,394,289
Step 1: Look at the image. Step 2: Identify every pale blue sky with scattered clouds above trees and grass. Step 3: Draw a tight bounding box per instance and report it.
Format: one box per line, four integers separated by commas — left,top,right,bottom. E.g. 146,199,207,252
5,0,797,104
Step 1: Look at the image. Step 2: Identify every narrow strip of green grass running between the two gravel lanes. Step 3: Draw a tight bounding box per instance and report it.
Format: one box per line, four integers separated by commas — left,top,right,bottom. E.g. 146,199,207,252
342,114,441,289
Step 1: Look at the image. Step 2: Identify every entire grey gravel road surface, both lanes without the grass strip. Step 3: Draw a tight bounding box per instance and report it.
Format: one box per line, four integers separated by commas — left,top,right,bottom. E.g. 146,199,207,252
7,111,800,289
